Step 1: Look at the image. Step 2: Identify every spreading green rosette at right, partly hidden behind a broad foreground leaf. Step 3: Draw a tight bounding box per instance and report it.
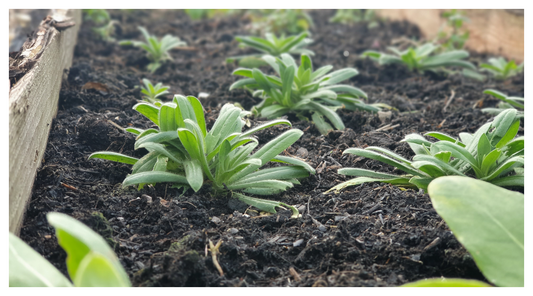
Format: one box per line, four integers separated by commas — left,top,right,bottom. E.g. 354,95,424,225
329,109,524,191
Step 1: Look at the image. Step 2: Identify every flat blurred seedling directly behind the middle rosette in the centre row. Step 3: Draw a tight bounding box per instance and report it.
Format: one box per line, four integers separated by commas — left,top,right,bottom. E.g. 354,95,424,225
226,33,315,63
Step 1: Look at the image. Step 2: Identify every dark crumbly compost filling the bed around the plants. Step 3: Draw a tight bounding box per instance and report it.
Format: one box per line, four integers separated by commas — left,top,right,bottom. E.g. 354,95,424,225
21,10,524,286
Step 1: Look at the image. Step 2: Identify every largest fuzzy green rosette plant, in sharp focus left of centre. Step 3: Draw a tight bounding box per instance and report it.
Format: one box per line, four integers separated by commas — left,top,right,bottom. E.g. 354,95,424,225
89,95,315,216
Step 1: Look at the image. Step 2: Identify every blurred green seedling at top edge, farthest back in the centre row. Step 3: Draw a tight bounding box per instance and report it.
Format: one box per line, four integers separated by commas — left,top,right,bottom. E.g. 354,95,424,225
248,9,314,35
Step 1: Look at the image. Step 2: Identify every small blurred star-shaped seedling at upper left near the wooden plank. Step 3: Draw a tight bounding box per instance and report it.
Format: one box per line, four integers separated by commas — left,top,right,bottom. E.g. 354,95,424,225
120,27,187,73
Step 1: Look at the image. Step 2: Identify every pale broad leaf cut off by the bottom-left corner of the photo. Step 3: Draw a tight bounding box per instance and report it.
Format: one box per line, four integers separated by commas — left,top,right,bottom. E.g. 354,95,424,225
9,232,72,287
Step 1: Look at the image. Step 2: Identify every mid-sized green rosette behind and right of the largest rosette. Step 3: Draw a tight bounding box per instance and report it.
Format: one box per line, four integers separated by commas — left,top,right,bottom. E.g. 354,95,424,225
230,54,380,134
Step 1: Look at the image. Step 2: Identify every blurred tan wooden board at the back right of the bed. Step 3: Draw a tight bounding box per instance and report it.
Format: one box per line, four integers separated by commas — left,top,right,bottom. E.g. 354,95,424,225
376,9,524,62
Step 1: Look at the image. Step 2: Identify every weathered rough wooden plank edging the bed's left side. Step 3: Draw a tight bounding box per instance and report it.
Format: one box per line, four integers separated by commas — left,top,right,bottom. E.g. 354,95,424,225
9,9,81,235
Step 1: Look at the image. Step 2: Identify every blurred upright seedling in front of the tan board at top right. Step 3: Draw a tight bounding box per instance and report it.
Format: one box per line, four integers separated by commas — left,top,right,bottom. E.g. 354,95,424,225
437,9,470,50
